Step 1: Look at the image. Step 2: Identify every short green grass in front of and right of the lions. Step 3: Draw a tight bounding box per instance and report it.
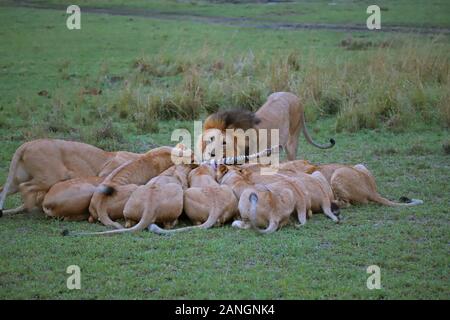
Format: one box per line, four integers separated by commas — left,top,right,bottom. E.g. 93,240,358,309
0,121,450,299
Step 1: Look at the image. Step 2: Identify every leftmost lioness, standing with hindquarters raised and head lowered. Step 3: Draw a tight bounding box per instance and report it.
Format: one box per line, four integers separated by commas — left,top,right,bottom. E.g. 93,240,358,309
0,139,139,216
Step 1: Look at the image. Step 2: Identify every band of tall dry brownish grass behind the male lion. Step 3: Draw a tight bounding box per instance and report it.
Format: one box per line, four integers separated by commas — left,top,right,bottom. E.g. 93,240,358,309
107,40,450,131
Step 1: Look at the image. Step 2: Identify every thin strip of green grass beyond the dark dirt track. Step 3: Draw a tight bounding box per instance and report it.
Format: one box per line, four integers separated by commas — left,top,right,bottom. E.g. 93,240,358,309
12,0,450,27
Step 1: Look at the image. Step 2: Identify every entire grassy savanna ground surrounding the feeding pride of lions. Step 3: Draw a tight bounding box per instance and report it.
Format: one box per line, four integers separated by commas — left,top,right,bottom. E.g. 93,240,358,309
0,0,450,299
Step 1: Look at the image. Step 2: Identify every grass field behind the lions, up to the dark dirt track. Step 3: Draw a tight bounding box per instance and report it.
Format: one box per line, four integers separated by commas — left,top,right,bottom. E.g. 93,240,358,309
0,9,450,136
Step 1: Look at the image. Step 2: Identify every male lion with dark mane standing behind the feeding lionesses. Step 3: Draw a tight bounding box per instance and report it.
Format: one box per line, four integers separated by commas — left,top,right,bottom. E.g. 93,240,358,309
198,92,335,160
